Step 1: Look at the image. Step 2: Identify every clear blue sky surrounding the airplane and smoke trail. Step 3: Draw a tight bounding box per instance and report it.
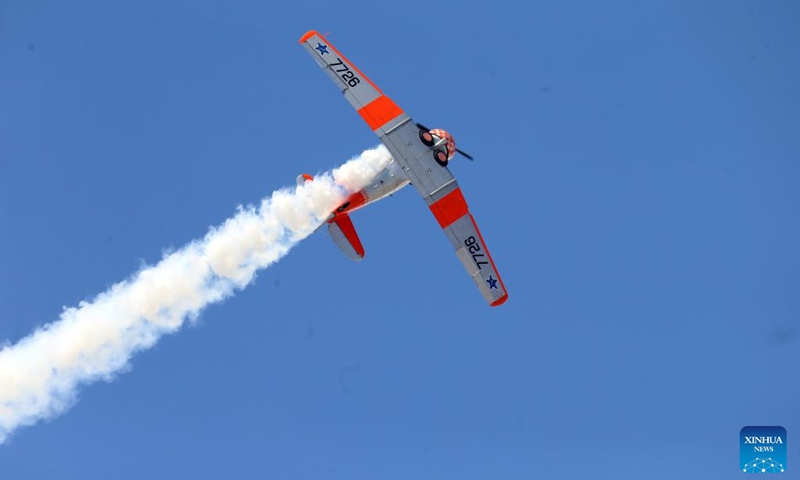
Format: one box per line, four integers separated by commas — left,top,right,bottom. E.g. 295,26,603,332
0,0,800,479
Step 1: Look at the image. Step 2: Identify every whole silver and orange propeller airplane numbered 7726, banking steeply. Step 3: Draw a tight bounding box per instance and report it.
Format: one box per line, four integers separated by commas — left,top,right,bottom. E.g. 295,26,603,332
297,30,508,307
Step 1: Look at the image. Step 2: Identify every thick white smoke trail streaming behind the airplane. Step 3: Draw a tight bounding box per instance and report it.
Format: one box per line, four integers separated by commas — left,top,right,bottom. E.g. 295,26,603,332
0,145,391,443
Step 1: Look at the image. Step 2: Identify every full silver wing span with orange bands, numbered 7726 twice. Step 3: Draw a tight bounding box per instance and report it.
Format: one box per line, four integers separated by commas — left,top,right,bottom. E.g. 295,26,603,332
300,30,508,306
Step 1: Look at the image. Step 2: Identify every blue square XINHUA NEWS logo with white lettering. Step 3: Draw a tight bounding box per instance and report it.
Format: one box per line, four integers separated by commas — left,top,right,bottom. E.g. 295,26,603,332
739,427,786,473
